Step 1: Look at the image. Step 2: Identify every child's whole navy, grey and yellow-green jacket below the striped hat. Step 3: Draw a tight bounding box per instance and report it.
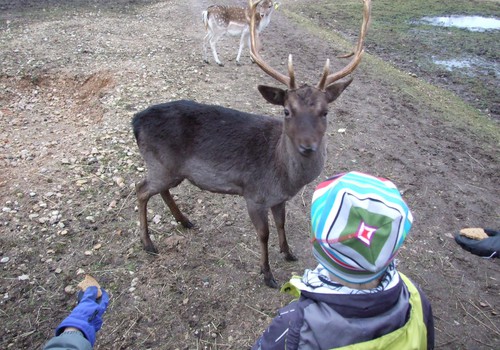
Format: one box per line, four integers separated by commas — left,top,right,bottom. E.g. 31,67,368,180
253,265,434,350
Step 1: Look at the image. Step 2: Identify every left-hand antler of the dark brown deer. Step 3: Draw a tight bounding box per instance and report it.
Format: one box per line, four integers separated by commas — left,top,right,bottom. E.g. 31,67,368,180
248,0,295,89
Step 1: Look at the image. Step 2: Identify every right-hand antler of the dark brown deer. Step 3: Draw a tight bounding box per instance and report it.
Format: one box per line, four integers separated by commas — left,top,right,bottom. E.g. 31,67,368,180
317,0,371,90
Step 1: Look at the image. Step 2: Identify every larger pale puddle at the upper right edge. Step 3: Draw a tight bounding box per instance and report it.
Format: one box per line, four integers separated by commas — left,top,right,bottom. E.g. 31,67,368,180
421,16,500,32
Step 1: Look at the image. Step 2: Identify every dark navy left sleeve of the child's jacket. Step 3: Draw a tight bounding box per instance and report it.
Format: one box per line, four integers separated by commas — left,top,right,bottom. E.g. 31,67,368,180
252,301,302,350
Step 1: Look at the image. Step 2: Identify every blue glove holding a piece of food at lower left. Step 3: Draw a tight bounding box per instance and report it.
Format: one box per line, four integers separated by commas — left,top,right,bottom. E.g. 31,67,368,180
56,287,109,346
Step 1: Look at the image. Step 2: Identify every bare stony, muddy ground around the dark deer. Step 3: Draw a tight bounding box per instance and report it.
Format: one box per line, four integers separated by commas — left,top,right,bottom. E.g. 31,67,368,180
0,0,500,349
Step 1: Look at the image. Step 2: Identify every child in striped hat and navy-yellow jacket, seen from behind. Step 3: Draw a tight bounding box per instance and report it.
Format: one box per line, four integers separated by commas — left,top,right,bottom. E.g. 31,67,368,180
253,172,434,350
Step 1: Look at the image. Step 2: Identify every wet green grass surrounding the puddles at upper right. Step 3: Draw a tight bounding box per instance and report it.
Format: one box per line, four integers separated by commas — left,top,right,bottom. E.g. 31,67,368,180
283,0,500,118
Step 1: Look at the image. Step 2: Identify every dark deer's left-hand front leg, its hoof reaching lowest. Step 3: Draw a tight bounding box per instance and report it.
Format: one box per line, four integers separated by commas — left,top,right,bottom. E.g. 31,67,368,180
247,200,278,288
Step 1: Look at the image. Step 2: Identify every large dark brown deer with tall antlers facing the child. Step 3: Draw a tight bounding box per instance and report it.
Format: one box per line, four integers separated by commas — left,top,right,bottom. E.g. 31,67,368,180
132,0,371,288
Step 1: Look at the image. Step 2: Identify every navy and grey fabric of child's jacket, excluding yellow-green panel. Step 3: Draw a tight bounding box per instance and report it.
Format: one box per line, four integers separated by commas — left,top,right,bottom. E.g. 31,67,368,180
252,268,434,350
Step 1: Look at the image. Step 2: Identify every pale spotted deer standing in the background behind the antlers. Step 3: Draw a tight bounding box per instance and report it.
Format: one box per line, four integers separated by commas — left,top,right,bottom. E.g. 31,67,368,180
202,0,279,66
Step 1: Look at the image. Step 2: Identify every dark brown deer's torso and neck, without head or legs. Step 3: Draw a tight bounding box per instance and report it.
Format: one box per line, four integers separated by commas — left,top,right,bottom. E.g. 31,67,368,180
132,101,326,205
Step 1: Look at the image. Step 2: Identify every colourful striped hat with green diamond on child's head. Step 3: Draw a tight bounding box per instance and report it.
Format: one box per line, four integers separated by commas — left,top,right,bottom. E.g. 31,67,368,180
311,172,413,284
